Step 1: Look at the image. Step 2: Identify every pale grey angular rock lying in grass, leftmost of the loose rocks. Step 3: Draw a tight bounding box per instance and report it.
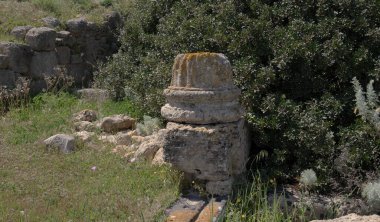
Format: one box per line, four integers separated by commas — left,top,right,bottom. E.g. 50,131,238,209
44,134,75,153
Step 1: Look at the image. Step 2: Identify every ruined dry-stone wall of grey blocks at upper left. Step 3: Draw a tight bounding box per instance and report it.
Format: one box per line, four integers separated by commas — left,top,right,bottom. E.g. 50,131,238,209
0,13,122,94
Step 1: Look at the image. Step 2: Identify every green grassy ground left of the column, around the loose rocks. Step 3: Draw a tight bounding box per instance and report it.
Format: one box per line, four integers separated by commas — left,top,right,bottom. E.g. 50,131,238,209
0,94,179,221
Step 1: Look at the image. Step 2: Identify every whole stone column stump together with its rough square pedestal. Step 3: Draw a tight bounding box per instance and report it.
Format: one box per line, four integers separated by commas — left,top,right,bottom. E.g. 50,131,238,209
161,53,248,195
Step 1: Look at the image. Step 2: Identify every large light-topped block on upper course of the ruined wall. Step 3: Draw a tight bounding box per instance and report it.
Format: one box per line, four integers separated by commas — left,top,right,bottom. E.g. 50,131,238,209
25,27,57,51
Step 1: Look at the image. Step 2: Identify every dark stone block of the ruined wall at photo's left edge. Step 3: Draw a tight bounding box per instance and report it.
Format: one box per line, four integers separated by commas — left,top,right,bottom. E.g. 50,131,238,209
0,42,32,74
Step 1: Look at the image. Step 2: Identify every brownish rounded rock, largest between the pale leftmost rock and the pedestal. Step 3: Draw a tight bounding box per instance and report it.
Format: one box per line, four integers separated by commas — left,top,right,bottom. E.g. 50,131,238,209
100,114,136,133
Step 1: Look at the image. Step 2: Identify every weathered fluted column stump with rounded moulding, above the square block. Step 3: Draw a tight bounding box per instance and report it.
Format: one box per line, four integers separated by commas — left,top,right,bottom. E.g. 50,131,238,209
161,53,243,124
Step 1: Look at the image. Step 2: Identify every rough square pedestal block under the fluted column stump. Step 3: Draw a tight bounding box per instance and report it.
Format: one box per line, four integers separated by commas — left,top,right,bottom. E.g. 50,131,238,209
162,120,249,195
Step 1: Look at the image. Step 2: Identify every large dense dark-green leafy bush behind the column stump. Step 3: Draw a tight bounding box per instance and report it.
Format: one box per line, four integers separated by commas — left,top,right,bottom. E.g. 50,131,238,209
96,0,380,193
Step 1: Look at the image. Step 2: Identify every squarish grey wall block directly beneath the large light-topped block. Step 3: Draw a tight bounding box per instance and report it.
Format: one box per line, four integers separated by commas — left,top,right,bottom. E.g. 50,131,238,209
30,51,58,79
